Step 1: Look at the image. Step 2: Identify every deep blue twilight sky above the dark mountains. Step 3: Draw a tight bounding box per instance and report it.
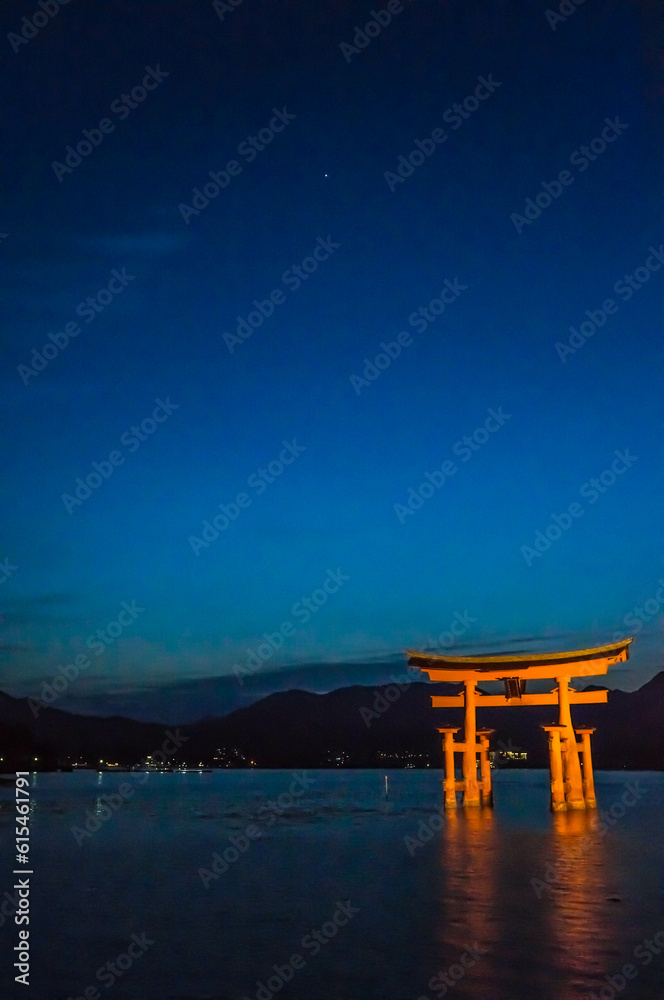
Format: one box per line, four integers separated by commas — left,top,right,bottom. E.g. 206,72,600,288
0,0,664,712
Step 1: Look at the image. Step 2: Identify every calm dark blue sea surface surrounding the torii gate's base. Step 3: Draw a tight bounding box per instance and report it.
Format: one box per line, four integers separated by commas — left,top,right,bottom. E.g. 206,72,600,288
0,770,664,1000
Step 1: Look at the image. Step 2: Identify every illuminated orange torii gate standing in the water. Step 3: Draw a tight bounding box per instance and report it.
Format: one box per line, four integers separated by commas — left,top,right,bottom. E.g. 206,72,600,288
406,638,632,812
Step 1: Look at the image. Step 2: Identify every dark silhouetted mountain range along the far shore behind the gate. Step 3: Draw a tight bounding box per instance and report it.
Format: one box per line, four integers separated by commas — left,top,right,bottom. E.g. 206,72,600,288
0,672,664,771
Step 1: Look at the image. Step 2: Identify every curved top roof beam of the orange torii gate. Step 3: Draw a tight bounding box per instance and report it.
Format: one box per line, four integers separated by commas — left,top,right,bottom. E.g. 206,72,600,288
406,636,633,681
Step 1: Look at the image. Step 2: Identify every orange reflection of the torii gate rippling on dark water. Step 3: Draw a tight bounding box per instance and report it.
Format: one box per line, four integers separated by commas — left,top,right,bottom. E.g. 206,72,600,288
438,809,618,1000
